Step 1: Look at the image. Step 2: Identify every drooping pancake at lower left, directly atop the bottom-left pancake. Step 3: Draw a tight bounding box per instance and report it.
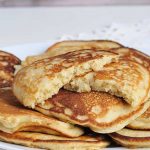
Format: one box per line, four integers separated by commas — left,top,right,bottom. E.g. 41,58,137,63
0,90,83,137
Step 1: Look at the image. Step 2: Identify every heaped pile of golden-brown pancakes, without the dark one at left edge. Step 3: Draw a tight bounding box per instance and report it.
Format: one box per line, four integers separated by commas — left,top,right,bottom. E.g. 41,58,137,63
0,40,150,149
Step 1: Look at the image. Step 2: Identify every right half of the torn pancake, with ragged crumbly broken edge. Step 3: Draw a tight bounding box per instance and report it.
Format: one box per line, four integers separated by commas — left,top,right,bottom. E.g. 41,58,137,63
65,60,150,107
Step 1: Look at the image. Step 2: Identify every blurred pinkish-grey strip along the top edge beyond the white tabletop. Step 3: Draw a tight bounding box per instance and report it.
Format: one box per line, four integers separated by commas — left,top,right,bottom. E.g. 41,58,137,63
0,0,150,7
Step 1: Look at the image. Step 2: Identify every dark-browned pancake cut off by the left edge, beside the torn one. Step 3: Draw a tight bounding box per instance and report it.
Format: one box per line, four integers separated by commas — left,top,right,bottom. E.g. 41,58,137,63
0,50,20,88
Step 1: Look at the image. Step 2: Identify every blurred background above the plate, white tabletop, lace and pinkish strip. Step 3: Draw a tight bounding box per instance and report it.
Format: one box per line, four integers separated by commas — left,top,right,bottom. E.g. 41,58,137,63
0,0,150,51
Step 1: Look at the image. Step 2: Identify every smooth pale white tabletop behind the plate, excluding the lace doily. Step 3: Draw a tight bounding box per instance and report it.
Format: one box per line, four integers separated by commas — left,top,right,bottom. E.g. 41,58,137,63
0,6,150,47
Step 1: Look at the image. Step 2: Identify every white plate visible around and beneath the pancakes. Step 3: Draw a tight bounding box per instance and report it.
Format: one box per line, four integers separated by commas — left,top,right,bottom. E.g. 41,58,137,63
0,40,150,150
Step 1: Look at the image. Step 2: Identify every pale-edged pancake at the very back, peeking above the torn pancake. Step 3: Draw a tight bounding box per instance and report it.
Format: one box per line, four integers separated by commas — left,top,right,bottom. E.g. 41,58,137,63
46,40,123,57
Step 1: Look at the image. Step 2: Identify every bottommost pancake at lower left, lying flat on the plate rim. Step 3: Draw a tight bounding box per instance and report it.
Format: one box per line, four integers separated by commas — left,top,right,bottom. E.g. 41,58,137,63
0,132,110,150
